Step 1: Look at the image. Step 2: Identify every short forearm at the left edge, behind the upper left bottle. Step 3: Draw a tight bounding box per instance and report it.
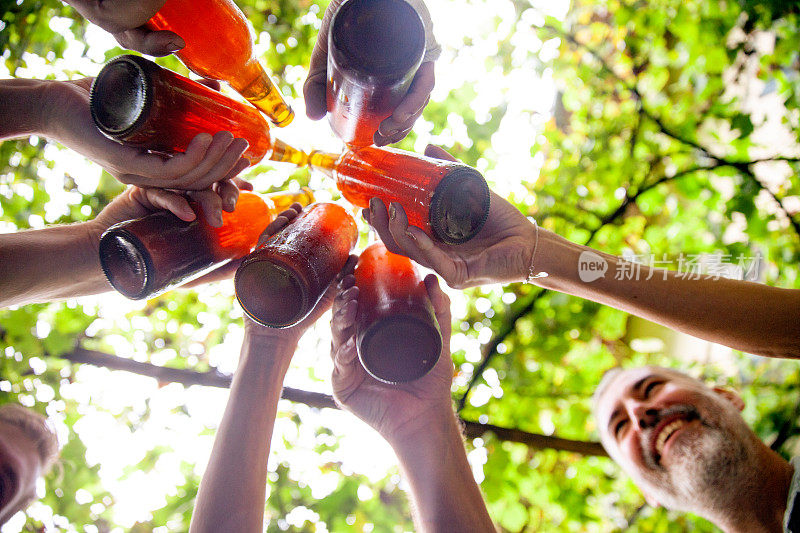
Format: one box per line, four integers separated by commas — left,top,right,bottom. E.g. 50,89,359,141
0,79,48,141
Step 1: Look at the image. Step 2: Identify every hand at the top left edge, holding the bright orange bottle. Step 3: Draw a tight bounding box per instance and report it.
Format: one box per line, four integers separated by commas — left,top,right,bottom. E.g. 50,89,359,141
64,0,186,56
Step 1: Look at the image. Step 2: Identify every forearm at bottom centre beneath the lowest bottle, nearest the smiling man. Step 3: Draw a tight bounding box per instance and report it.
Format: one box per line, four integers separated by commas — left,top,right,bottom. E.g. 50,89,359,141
390,406,495,533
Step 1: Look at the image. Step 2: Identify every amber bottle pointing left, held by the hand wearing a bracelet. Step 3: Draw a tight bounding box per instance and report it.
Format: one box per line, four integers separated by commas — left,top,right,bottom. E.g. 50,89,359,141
308,146,489,244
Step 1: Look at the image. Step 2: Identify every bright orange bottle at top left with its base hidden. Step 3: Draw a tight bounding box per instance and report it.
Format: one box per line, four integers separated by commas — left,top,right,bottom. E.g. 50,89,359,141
146,0,294,127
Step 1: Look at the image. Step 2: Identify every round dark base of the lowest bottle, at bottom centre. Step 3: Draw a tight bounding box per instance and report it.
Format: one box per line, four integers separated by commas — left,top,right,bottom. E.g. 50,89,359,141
356,315,442,383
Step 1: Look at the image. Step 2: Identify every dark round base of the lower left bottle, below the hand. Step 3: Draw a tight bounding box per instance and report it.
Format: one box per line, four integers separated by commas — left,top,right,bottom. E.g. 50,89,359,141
99,226,153,300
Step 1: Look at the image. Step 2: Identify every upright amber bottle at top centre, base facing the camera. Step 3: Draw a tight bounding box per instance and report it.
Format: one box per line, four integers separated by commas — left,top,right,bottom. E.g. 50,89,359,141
327,0,425,147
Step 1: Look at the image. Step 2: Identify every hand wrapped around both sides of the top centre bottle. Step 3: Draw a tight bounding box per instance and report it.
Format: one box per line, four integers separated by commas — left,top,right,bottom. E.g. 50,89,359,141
303,0,439,146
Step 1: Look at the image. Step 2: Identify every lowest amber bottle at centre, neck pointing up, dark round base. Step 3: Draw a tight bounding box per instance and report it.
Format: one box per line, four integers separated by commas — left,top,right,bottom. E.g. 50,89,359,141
355,243,442,383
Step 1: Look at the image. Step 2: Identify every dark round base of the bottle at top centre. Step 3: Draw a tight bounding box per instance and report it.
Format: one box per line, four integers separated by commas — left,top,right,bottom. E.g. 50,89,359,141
330,0,425,78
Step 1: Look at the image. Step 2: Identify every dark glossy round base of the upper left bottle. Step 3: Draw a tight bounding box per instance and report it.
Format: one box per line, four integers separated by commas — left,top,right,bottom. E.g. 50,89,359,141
89,55,153,139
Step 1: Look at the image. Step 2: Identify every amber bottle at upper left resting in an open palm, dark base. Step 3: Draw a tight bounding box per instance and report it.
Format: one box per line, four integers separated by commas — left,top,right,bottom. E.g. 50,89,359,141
89,55,306,165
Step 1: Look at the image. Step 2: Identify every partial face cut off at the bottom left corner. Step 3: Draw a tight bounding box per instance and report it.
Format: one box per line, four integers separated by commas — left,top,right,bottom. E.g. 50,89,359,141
0,420,41,524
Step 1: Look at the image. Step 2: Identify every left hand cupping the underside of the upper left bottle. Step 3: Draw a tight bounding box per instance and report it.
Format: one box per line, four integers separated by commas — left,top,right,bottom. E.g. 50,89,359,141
40,78,249,190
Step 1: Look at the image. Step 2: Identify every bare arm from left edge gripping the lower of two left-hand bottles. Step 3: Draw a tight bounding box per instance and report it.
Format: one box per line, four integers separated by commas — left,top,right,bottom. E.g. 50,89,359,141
0,184,245,307
